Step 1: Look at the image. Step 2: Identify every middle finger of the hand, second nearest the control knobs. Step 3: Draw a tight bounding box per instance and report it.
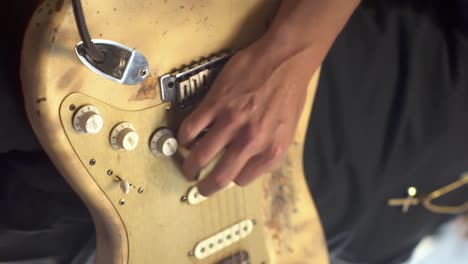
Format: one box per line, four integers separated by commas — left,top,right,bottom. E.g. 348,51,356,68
182,112,243,180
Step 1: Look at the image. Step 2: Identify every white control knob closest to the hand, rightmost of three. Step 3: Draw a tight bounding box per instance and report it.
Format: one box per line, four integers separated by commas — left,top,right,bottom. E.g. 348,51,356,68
150,128,179,157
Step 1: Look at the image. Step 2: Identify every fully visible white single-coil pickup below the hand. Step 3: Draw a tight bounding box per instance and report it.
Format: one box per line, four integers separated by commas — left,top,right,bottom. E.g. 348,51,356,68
193,219,254,259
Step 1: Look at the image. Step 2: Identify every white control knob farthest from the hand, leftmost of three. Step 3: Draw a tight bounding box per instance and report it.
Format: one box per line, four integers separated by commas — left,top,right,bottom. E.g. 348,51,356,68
73,105,104,134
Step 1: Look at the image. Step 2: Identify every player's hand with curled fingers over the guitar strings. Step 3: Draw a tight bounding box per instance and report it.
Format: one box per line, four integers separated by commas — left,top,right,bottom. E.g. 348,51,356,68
178,34,318,196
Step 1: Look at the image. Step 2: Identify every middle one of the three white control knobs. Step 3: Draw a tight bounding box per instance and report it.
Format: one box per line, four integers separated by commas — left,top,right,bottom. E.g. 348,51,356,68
110,122,139,150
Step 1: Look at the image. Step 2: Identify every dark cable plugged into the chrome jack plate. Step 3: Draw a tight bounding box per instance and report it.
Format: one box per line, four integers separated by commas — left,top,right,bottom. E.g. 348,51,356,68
72,0,105,63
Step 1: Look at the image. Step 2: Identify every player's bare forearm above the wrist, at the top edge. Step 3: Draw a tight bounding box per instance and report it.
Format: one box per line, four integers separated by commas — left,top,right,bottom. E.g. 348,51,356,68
259,0,360,66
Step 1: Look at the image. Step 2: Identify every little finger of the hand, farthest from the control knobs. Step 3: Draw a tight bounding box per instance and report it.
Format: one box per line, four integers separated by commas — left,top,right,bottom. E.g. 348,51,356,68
234,142,285,186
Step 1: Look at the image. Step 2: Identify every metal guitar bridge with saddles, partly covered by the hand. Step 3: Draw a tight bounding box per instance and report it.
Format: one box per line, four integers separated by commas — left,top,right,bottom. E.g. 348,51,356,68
159,52,231,110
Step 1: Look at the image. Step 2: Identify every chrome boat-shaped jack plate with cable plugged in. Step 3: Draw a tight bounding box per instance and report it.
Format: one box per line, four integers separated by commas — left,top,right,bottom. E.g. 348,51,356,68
75,39,149,85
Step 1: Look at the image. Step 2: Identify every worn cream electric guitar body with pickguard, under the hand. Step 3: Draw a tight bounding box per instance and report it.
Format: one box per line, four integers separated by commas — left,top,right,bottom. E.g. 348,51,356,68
21,0,328,264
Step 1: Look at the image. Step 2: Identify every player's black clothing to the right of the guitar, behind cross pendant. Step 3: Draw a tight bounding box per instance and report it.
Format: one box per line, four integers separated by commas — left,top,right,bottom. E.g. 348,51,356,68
304,1,468,263
